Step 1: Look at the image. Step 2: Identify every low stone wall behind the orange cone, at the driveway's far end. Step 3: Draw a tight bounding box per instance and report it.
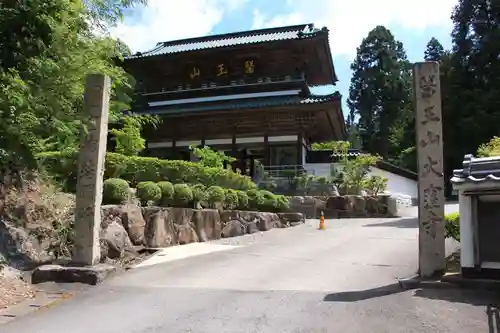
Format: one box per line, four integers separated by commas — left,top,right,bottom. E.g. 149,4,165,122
290,195,398,219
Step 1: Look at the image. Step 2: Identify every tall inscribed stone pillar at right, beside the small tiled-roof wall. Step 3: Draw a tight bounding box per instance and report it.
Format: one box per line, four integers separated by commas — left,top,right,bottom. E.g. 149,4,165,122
413,62,446,277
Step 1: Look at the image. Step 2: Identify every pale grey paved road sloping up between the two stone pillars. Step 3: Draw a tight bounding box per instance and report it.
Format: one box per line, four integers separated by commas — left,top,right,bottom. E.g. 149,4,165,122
0,204,498,333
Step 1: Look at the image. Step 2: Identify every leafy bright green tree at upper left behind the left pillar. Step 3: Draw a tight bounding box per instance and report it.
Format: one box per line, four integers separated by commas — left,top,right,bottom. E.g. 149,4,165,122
0,0,144,175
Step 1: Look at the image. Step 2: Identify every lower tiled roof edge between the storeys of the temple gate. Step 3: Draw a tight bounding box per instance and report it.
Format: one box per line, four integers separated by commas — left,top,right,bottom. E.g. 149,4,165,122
146,92,341,114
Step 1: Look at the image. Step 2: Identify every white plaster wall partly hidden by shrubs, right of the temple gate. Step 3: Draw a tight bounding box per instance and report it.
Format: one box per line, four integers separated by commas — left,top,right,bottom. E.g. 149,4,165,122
304,163,418,198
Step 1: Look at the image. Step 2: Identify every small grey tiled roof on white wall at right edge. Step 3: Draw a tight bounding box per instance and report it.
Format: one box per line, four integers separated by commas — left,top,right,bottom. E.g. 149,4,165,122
451,155,500,185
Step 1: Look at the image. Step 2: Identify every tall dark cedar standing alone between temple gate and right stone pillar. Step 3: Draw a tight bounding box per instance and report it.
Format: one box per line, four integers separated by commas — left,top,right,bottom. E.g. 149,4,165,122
347,26,411,158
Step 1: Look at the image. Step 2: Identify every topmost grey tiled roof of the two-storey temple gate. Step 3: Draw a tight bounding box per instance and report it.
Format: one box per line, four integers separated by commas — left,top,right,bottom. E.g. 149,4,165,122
127,24,325,59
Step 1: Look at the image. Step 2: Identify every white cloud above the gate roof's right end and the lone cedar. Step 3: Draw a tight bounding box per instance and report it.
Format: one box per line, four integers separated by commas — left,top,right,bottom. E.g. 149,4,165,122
253,0,456,56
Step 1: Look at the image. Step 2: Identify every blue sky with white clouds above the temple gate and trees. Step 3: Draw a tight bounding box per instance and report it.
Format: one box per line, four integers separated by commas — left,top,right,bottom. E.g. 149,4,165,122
111,0,457,112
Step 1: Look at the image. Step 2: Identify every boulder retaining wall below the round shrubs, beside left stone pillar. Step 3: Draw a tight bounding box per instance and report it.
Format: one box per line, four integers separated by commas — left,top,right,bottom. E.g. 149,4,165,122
100,205,305,253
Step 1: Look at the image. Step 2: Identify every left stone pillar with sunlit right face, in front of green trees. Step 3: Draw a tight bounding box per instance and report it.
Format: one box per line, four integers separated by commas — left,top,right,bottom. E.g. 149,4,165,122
73,74,111,265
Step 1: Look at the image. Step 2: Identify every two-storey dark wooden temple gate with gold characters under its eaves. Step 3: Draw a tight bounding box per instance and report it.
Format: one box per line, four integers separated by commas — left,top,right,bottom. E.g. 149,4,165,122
123,24,347,178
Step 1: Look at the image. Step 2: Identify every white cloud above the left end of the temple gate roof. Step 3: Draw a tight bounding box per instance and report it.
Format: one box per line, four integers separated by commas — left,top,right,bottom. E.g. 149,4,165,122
110,0,247,52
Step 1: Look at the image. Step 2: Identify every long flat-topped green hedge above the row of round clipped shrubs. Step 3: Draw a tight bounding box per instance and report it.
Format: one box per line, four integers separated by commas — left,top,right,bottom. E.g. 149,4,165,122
37,152,256,192
